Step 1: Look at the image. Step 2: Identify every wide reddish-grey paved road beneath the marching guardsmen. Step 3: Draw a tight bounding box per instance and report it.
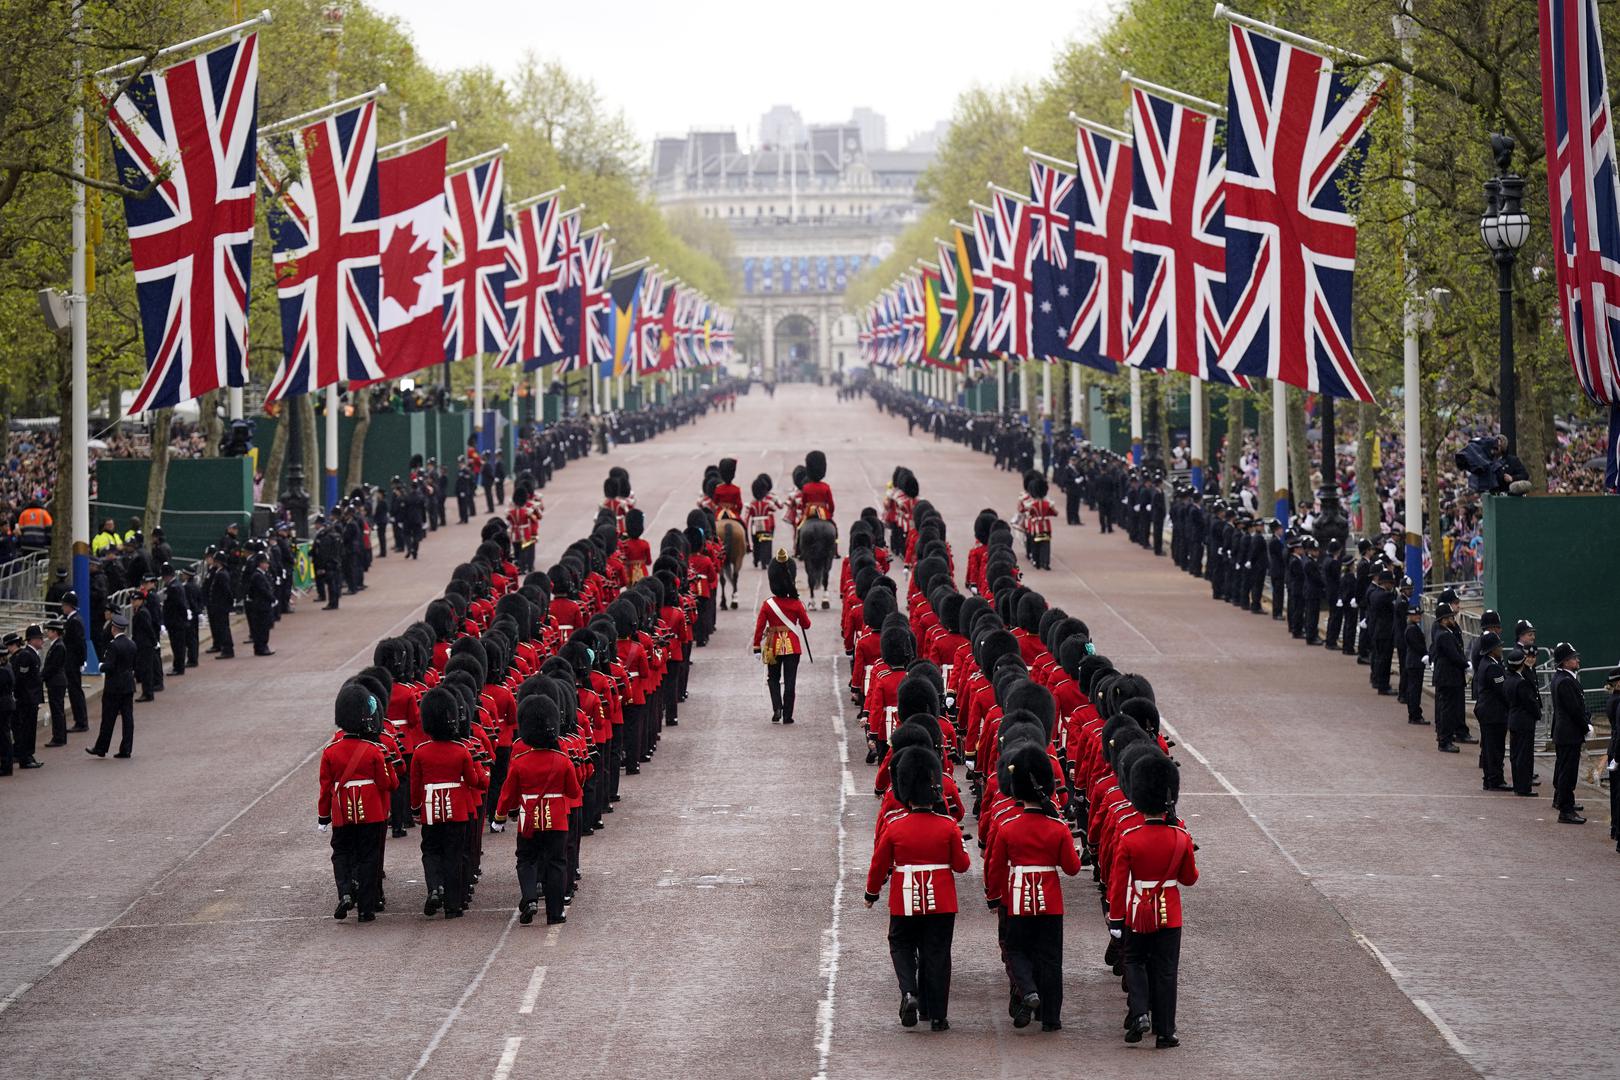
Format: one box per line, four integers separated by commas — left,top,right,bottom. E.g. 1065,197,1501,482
0,387,1620,1078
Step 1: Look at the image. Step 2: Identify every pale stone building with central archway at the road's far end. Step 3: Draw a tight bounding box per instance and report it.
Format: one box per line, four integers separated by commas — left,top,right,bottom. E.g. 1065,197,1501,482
650,105,933,379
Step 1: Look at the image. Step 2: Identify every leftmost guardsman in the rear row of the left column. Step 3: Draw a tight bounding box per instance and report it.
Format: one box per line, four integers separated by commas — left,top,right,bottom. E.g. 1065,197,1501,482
316,682,397,923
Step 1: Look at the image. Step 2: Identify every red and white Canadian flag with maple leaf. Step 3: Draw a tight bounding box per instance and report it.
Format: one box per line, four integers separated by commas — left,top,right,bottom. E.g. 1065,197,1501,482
377,139,446,379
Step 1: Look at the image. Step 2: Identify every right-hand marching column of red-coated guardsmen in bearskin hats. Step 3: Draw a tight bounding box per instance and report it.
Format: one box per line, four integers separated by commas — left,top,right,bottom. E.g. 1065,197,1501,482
841,470,1197,1049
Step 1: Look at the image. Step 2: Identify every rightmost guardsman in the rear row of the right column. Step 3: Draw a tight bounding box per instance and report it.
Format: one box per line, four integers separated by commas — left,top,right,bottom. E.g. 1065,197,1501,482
1108,755,1199,1049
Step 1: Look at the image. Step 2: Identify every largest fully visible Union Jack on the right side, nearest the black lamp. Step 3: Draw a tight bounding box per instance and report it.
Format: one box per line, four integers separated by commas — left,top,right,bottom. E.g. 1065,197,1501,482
1220,26,1382,402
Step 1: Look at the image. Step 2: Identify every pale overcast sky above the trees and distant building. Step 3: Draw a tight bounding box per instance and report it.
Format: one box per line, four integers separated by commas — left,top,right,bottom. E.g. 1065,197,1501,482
373,0,1108,149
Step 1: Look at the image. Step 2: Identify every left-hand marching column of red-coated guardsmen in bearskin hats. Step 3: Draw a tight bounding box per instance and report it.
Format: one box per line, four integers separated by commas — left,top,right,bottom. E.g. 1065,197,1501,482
318,468,718,925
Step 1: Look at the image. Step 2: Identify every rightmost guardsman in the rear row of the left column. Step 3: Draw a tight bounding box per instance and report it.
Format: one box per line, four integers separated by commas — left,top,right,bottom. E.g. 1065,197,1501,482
496,693,582,926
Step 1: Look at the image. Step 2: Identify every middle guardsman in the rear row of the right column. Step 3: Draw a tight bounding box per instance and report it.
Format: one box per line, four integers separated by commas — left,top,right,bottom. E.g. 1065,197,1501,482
985,740,1081,1031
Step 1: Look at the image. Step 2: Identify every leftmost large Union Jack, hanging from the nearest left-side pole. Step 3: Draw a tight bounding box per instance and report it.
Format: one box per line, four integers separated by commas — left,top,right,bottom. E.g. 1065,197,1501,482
102,34,259,413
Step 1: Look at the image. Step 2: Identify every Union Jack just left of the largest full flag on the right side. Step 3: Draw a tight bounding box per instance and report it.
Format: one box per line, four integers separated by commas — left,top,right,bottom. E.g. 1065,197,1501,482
1124,87,1247,385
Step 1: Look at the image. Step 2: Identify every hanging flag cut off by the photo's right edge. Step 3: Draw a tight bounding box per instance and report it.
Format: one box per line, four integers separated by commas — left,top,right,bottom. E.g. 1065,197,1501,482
1541,0,1620,492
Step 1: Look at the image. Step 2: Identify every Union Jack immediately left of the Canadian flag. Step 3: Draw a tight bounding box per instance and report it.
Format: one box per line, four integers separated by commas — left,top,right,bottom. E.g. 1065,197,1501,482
259,102,384,402
